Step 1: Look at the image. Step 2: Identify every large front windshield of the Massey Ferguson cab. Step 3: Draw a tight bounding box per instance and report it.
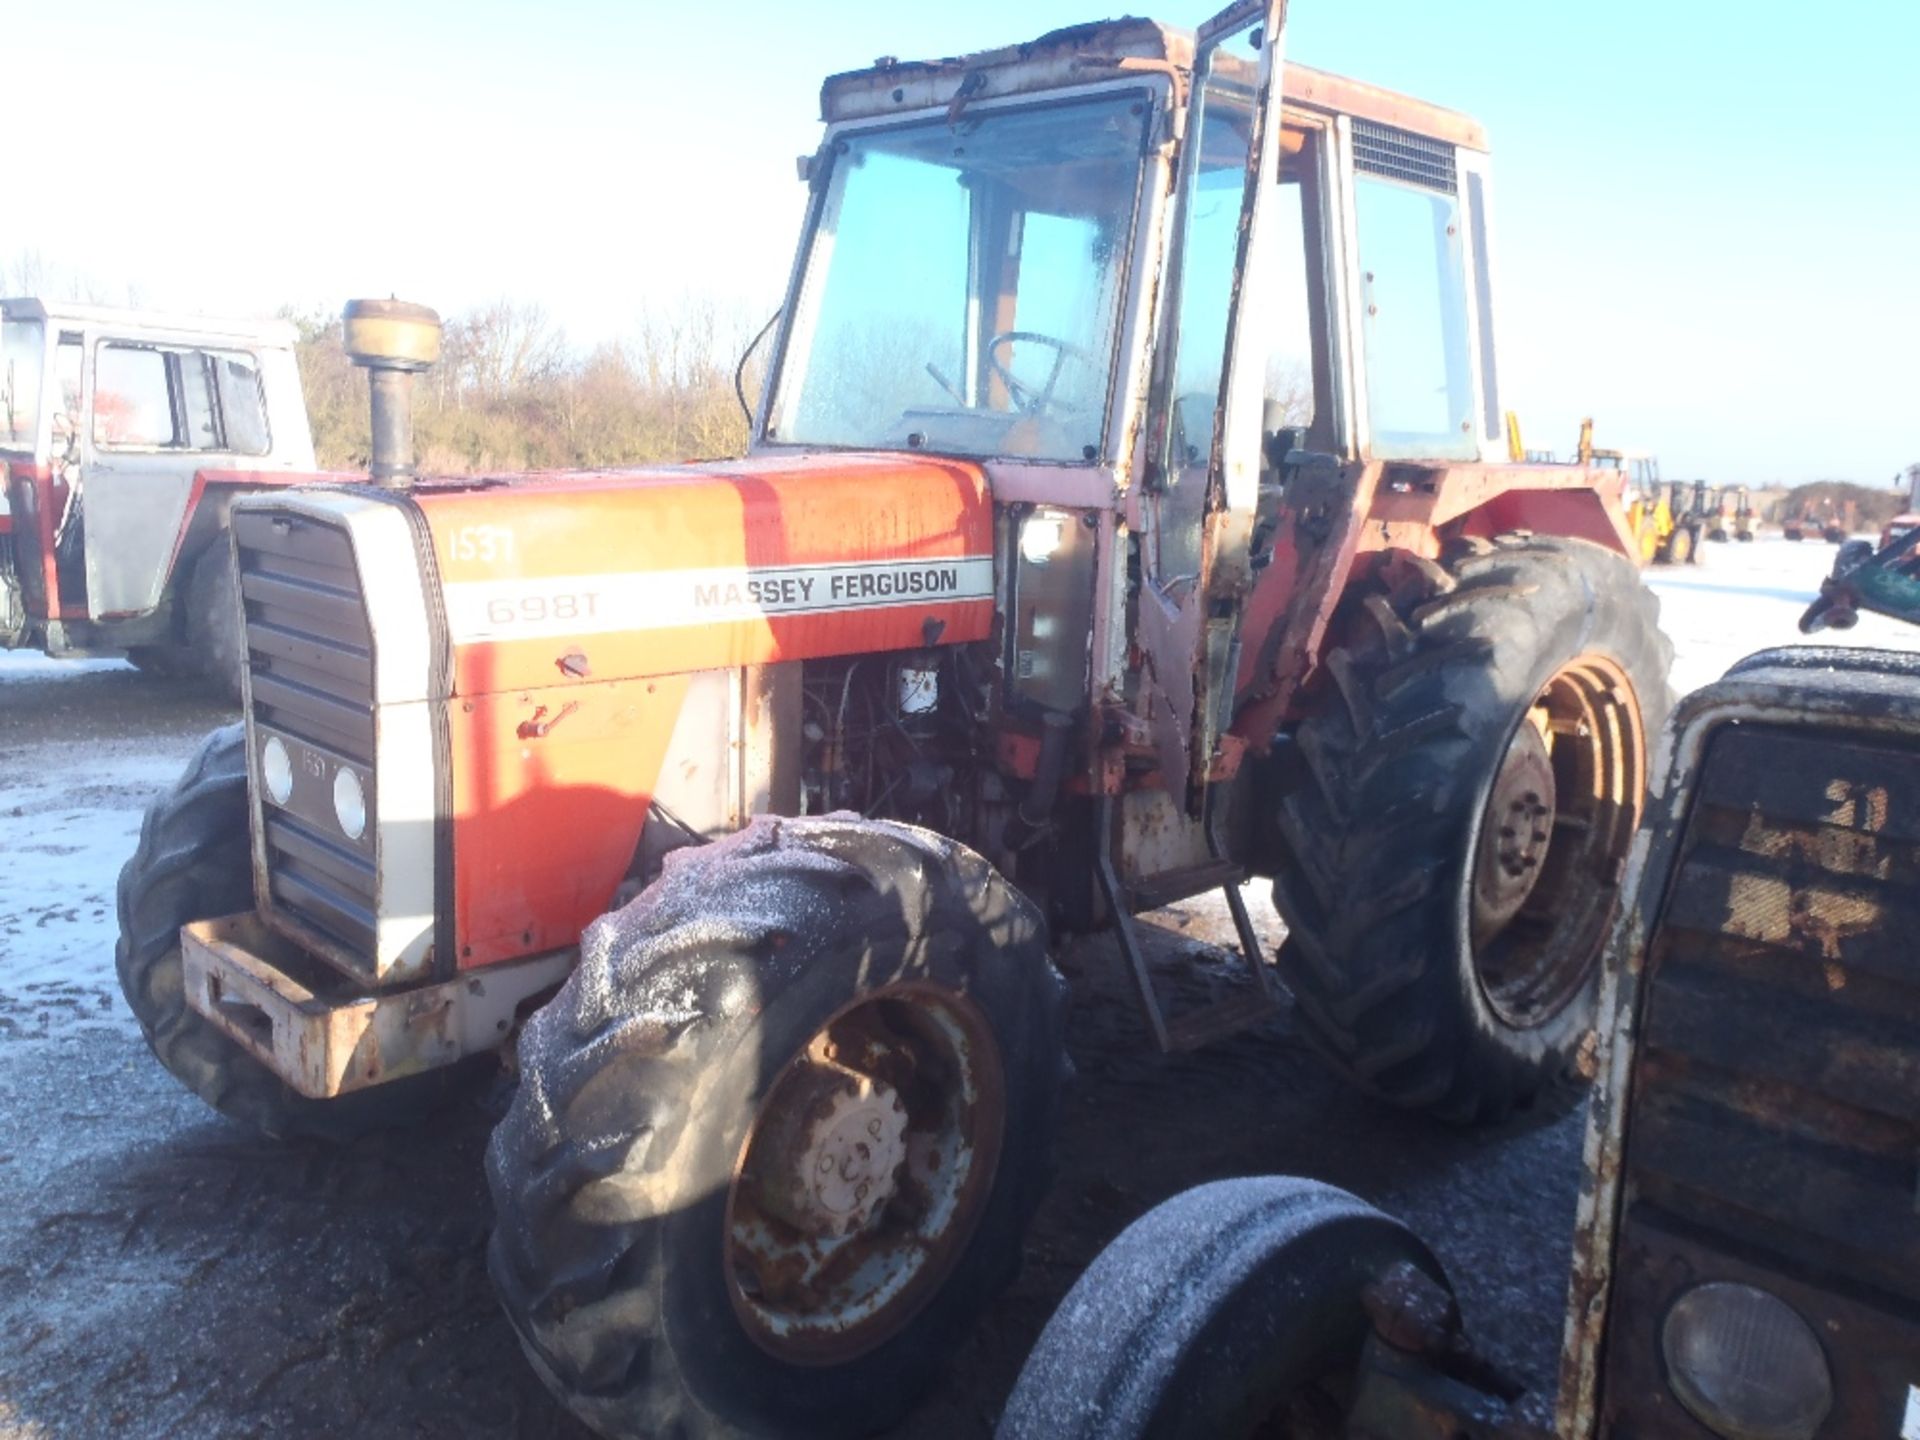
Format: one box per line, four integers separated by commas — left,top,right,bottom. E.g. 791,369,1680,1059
768,92,1148,461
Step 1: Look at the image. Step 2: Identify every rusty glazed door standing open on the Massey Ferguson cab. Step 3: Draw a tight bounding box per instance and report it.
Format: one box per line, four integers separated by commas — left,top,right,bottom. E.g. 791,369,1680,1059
1139,0,1286,816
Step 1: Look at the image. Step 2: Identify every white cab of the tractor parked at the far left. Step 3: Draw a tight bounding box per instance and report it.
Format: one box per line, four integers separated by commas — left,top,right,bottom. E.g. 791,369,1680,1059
0,300,313,695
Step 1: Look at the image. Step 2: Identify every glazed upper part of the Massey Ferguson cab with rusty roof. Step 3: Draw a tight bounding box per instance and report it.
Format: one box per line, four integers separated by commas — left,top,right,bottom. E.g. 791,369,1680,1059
755,4,1501,493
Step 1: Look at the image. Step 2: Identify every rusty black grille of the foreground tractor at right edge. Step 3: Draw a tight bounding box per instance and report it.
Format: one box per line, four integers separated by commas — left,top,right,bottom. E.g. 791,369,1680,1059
1603,724,1920,1434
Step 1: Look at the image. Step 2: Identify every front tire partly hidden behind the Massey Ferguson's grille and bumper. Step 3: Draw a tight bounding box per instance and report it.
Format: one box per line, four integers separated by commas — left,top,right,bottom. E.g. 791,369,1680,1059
113,726,480,1140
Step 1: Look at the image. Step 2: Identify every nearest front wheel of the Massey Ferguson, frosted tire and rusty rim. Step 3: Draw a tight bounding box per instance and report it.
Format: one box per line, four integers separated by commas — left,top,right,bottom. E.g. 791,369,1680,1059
488,818,1066,1436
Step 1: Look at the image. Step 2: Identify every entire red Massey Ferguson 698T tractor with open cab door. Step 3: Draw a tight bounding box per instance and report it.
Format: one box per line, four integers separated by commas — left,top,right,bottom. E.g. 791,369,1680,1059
119,0,1668,1436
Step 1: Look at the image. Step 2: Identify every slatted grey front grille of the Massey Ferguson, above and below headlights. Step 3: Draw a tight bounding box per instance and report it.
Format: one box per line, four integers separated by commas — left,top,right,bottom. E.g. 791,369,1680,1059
234,511,378,964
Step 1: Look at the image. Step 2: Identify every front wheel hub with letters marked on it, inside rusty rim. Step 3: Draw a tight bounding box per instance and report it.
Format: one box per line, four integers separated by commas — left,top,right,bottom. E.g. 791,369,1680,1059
756,1060,906,1236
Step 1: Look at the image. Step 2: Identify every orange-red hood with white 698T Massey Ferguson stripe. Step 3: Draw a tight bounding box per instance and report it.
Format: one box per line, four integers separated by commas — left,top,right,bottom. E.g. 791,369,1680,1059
411,453,995,695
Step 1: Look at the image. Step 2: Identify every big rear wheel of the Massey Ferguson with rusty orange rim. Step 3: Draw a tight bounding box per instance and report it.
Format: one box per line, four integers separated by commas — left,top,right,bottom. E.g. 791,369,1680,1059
1273,536,1672,1123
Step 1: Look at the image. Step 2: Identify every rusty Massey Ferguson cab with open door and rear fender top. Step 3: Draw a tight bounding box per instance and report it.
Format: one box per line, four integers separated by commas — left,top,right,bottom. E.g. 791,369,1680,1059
753,2,1630,814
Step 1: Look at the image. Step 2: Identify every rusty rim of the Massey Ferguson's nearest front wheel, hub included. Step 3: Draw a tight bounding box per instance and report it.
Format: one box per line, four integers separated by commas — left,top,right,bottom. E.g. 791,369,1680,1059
724,983,1006,1363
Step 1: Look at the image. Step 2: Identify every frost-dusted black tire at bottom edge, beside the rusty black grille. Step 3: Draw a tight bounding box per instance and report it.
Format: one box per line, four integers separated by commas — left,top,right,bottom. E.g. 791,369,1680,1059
995,1177,1450,1440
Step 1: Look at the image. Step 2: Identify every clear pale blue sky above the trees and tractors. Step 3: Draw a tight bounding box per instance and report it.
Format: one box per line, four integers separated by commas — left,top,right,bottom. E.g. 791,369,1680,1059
0,0,1920,484
